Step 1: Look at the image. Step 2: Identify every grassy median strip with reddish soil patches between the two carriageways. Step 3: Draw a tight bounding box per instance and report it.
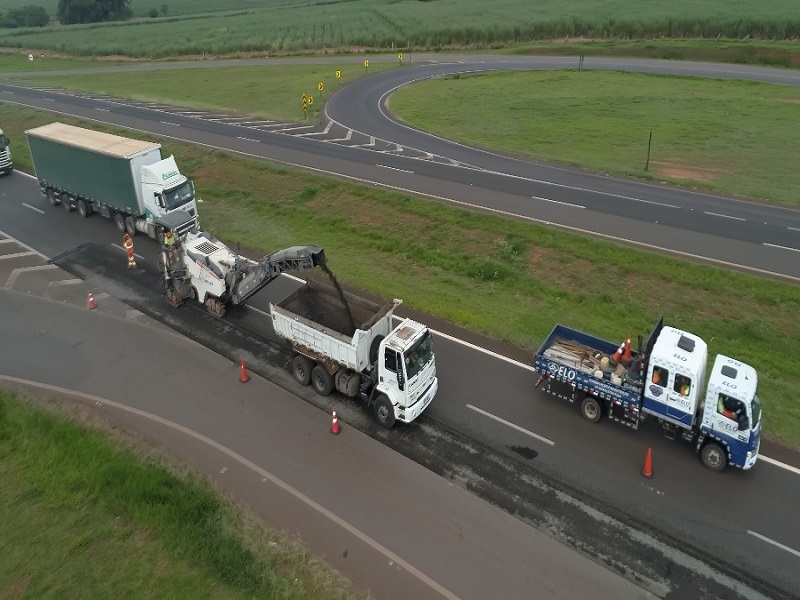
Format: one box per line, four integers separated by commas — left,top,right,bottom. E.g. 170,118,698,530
0,105,800,448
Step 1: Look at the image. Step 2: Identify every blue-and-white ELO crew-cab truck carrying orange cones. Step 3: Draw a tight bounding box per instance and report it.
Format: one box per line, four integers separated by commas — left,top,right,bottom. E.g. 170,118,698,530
534,318,762,472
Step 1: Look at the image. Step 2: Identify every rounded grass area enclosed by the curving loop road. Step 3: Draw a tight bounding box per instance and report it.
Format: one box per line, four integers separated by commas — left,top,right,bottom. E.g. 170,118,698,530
390,71,800,205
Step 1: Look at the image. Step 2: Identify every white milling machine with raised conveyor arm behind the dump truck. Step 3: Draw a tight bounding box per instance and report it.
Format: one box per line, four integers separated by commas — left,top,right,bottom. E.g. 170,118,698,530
156,211,325,317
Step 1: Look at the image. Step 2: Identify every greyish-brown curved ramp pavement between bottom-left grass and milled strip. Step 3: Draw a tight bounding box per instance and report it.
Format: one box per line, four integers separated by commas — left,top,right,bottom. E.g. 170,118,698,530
0,288,651,600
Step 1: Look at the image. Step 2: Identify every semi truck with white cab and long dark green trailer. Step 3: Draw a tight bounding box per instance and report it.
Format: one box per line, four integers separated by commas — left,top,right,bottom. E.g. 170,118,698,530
25,123,199,241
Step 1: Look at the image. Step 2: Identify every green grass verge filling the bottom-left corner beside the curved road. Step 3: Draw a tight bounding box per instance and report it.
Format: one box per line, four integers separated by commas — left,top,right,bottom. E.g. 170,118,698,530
0,390,366,600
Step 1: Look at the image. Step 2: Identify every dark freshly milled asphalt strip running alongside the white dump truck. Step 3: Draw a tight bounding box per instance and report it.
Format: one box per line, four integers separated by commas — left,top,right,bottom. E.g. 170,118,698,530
51,234,791,598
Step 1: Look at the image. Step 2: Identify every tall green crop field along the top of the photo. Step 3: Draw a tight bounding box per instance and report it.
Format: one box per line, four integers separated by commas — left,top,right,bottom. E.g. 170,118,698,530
0,0,800,58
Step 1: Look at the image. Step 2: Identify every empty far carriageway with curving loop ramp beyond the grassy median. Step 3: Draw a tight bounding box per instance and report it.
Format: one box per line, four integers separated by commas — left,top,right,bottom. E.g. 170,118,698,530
0,57,800,281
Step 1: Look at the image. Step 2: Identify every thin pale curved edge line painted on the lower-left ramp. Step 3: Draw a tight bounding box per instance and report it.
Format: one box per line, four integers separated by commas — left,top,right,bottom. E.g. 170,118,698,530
0,374,459,600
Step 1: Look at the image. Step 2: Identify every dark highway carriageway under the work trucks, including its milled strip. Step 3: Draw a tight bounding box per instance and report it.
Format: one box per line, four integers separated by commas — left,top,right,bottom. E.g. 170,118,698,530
0,174,800,597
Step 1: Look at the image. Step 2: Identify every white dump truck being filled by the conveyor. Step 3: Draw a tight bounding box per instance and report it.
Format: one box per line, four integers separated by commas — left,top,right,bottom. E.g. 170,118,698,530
270,279,439,429
